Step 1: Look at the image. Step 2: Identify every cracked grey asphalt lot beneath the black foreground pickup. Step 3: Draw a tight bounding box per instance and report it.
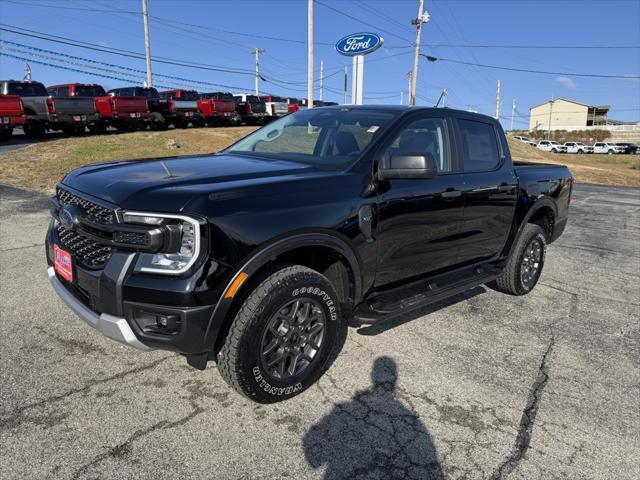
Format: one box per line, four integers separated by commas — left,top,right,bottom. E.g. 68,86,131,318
0,185,640,480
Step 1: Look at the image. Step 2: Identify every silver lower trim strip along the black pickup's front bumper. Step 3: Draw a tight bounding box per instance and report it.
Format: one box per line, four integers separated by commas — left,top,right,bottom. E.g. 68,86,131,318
47,267,152,351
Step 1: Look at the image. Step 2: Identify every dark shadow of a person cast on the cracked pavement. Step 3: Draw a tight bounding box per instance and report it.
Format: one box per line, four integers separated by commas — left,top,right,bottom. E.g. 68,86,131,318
303,357,444,480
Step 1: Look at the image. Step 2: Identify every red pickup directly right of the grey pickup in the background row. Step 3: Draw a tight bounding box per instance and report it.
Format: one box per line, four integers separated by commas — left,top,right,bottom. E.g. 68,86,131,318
49,83,149,133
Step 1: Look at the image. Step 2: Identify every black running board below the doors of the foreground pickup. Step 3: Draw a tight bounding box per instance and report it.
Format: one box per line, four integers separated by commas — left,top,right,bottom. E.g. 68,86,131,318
353,265,500,325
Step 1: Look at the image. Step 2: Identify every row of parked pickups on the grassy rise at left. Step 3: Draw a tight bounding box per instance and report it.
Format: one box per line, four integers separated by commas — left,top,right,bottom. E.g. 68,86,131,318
0,80,336,140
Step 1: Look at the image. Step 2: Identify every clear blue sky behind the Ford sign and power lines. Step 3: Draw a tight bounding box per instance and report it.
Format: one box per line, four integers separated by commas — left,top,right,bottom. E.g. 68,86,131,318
0,0,640,127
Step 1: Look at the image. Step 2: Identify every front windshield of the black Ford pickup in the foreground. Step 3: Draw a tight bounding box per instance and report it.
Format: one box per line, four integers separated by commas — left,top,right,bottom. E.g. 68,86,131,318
226,109,395,169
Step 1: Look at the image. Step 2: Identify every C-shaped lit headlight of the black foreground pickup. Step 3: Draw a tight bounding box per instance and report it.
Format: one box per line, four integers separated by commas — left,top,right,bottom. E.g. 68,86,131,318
123,212,200,275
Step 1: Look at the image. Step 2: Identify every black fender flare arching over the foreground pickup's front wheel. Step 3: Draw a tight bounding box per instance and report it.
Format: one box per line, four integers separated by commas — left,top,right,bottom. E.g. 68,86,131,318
204,232,362,347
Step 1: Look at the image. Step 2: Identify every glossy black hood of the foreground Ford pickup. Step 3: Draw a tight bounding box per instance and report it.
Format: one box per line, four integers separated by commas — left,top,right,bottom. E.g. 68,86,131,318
62,154,319,212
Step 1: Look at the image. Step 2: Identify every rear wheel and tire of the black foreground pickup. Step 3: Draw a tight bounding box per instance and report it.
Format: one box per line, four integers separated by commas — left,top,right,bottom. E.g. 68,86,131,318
496,223,547,295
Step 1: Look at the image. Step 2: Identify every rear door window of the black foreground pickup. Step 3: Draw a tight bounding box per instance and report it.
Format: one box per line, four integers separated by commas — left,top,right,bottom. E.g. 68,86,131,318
458,119,500,172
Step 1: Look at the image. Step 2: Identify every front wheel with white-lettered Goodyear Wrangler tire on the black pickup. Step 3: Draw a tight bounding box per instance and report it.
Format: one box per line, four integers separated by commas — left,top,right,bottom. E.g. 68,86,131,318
218,265,341,403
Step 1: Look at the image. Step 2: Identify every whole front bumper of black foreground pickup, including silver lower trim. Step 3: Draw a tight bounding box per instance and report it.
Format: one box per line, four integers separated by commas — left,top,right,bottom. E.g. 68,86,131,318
46,212,229,355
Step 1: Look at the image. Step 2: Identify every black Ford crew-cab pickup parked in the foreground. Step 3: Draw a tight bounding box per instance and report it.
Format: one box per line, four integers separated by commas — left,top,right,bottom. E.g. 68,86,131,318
46,106,573,403
